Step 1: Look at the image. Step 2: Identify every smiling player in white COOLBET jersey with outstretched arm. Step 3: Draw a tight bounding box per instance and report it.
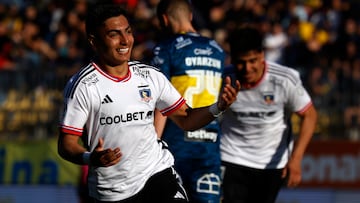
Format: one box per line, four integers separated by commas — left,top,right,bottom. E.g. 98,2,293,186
58,4,240,203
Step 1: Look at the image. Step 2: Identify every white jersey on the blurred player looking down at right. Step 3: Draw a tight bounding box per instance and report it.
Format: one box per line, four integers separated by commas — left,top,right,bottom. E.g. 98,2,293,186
220,62,312,169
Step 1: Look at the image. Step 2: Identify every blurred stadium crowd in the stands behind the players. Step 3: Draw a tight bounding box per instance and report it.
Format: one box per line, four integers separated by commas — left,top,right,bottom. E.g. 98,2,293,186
0,0,360,140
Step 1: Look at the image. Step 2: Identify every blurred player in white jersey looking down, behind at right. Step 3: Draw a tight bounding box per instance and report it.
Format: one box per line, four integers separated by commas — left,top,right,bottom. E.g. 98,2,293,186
220,26,317,203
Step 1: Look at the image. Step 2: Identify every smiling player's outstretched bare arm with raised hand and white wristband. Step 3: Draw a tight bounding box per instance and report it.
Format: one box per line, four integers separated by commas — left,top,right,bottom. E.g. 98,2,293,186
169,77,240,131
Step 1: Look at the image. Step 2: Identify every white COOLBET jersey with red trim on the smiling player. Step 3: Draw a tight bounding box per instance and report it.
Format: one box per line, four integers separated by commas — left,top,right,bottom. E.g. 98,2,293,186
61,61,185,201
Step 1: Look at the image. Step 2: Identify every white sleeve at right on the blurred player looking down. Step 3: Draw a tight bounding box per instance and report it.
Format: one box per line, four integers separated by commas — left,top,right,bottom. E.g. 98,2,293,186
286,69,312,113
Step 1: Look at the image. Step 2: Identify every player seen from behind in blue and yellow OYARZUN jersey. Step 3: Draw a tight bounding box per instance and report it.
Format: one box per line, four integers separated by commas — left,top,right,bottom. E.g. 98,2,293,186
152,0,225,203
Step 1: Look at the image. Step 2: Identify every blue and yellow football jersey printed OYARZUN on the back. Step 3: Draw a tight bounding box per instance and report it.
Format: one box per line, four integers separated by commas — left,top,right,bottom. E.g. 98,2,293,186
151,33,225,161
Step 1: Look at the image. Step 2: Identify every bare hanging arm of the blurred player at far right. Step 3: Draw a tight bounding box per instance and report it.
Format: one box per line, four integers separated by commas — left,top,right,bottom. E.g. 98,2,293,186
283,106,317,187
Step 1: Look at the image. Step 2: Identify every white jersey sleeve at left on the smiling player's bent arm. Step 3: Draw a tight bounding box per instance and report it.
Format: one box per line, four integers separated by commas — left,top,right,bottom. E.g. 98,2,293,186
60,78,89,136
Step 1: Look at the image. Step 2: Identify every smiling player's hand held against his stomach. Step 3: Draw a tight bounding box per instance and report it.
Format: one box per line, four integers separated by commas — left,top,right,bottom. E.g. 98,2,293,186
90,138,122,167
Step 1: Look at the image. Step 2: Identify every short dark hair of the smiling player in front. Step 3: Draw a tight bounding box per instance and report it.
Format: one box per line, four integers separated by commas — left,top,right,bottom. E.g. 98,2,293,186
85,3,128,36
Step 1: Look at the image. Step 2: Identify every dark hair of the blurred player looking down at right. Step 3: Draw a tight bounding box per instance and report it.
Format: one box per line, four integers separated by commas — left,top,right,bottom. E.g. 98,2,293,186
228,26,264,56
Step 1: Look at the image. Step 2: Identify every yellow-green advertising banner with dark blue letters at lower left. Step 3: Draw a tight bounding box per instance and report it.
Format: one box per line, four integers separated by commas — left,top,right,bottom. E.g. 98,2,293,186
0,138,80,186
